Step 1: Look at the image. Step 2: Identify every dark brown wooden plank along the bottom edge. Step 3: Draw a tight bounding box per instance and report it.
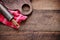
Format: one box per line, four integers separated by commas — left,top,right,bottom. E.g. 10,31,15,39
0,32,60,40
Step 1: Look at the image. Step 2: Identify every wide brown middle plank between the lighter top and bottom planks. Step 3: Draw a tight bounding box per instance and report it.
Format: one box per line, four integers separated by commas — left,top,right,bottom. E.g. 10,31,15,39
0,10,60,31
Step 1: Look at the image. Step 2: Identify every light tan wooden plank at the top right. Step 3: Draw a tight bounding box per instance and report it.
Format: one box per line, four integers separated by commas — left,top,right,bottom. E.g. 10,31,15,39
32,0,60,10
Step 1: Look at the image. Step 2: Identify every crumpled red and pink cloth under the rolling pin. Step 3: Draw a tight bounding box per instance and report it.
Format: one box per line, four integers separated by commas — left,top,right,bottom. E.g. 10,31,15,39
0,10,27,29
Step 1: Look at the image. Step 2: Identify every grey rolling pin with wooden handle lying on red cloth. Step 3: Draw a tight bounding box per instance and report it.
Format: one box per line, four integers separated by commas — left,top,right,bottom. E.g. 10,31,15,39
0,3,19,28
